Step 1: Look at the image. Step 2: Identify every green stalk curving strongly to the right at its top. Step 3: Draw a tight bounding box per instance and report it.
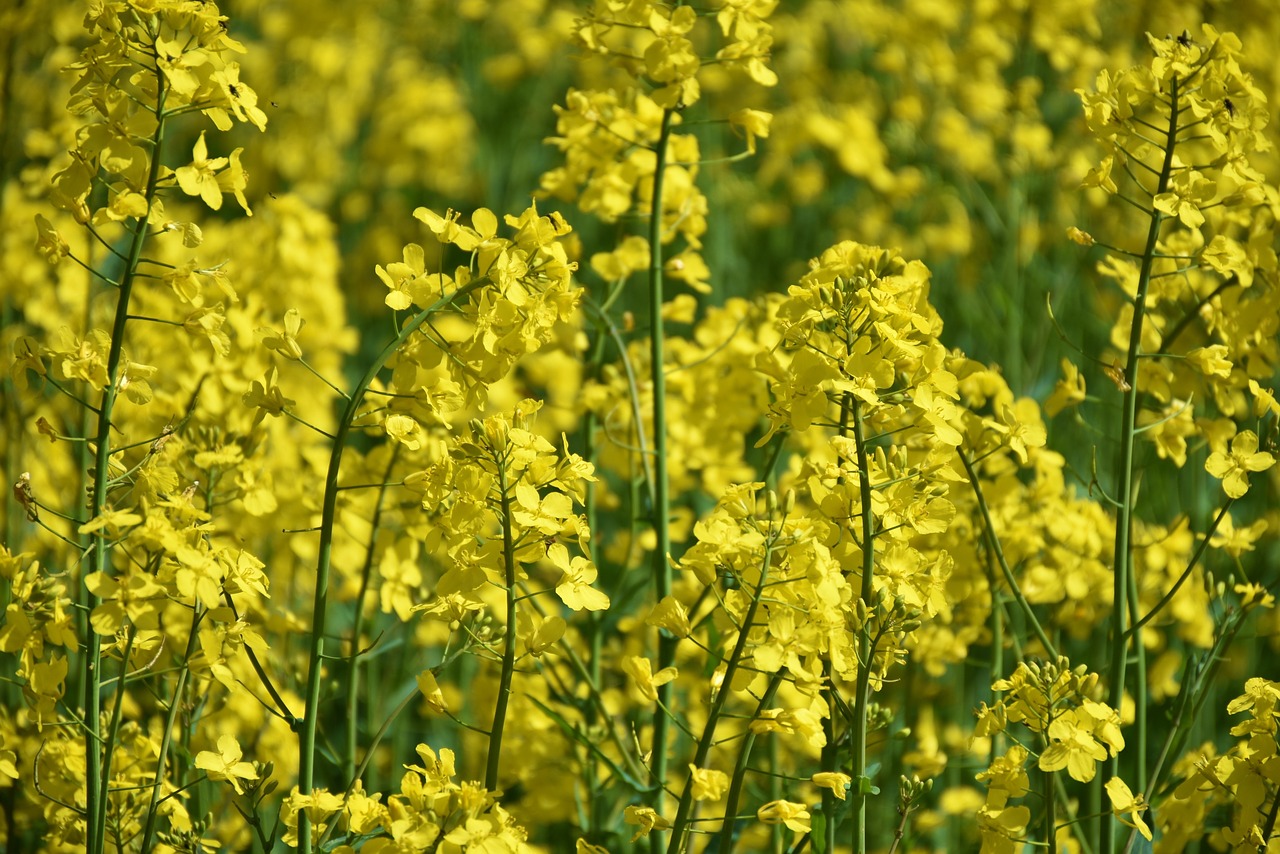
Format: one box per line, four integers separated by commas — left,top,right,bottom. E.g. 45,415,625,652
298,277,490,854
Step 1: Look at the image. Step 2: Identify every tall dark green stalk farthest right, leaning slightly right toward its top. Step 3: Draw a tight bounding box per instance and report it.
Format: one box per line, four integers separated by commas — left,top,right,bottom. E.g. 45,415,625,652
1101,77,1179,854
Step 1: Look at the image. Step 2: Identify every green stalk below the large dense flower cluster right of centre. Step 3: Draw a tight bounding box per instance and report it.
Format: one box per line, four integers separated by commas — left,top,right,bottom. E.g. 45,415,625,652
855,396,876,854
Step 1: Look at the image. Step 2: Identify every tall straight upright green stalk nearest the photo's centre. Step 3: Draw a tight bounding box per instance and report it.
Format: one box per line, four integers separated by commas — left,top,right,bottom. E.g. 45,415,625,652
650,109,680,839
